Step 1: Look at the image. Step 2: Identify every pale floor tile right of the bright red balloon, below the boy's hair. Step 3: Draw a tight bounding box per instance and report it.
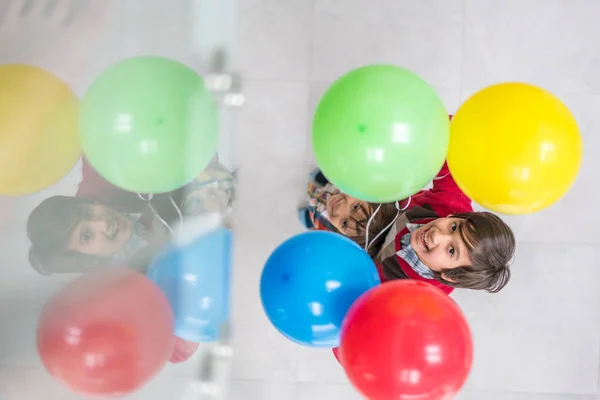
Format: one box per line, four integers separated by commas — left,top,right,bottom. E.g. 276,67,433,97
453,243,600,394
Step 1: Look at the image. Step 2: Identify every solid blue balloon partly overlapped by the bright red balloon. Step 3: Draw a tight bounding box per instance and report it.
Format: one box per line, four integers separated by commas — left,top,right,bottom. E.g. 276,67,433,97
260,231,381,348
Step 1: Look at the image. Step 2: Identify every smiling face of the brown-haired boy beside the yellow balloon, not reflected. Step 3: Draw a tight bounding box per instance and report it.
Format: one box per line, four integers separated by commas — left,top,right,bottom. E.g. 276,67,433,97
410,216,471,272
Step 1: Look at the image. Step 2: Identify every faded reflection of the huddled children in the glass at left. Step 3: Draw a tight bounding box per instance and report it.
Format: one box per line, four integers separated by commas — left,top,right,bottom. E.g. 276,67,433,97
27,158,234,274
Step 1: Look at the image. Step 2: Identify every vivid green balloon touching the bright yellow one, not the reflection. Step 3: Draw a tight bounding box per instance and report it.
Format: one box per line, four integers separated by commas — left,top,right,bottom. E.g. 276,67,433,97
312,65,450,203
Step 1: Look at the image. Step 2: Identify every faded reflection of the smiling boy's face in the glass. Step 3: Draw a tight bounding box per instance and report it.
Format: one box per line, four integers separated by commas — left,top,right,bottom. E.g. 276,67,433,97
69,204,132,257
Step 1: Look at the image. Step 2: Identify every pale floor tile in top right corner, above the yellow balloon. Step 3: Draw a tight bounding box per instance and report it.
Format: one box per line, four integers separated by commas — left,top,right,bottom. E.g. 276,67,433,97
462,0,600,93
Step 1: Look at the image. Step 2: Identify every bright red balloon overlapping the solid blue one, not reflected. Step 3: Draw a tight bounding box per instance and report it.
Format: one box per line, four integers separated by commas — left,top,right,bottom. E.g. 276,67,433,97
340,280,473,400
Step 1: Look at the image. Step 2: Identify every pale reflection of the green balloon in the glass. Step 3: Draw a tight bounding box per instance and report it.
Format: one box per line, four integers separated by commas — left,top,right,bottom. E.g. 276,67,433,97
79,56,219,193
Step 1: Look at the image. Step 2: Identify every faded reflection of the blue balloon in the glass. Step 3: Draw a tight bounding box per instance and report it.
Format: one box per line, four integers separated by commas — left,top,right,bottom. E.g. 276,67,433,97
147,228,232,343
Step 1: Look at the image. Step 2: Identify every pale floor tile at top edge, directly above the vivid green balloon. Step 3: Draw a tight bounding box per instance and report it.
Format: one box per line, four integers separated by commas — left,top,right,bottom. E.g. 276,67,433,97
309,0,463,88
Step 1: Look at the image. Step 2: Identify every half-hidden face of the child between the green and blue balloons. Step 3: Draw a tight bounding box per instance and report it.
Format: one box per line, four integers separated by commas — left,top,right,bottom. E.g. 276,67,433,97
327,193,369,236
